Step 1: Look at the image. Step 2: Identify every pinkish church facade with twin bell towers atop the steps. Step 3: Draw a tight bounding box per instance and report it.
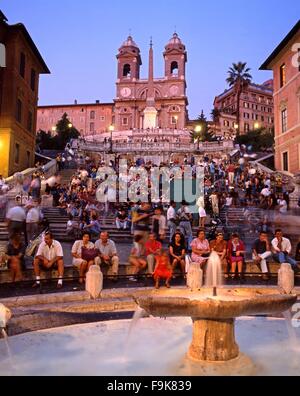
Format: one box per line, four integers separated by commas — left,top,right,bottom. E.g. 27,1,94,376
114,33,188,131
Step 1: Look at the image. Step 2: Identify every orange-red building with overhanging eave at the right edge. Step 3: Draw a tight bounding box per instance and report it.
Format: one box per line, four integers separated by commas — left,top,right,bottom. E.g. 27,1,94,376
261,20,300,174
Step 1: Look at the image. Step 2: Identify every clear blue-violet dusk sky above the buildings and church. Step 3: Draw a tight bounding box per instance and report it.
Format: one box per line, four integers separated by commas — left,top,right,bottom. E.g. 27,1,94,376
0,0,300,118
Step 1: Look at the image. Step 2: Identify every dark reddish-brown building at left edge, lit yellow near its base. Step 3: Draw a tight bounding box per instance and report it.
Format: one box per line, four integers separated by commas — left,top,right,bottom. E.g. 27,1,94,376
0,12,50,177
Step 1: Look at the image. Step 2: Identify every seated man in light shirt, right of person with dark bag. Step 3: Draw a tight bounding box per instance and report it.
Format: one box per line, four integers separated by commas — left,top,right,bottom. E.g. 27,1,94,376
95,232,120,282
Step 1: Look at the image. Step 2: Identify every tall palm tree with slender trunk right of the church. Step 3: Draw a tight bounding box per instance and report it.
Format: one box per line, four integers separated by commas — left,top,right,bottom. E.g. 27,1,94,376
226,62,252,132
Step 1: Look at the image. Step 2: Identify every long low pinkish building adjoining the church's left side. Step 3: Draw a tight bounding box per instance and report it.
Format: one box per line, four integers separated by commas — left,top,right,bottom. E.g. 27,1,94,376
37,101,114,136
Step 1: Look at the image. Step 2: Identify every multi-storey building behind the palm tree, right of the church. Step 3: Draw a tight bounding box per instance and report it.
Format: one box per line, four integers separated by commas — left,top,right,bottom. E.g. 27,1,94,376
214,80,274,136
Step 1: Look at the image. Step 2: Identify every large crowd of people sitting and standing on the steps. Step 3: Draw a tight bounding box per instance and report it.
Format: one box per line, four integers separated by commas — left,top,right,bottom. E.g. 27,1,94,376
0,144,300,288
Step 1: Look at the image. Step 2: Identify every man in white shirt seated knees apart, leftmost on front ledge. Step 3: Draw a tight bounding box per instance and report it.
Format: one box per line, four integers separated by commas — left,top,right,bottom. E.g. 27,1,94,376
33,232,64,289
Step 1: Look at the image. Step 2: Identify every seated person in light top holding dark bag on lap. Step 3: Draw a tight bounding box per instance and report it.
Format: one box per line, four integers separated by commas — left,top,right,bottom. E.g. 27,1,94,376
72,232,95,284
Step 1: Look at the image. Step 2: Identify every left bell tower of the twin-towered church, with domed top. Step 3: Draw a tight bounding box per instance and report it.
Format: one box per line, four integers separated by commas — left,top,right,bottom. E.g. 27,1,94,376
117,36,142,82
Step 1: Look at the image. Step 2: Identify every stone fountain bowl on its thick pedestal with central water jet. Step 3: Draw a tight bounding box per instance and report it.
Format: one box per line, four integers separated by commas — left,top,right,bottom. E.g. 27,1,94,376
137,253,297,368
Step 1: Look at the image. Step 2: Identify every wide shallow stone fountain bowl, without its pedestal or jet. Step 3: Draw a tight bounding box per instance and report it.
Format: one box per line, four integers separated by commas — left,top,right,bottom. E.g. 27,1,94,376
137,288,297,319
